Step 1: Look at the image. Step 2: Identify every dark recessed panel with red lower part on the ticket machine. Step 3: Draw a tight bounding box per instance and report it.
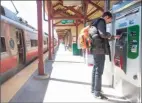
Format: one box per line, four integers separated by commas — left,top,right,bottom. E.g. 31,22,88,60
114,28,127,73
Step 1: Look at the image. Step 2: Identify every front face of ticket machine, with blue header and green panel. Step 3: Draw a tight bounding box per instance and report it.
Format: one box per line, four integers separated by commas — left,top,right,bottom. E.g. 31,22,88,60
114,8,141,85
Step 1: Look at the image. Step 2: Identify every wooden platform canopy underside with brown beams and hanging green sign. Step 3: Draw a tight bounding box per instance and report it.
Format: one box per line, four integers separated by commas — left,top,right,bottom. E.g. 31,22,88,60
44,0,122,35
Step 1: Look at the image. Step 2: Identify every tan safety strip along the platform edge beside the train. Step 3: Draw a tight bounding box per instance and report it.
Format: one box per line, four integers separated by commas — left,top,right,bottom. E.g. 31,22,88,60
1,52,48,103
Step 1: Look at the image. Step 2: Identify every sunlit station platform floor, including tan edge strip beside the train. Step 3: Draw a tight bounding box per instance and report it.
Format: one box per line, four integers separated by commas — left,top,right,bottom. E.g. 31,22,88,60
2,44,128,103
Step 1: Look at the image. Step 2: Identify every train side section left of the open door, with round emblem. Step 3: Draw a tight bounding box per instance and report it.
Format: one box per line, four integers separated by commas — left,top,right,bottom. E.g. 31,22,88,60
0,17,18,81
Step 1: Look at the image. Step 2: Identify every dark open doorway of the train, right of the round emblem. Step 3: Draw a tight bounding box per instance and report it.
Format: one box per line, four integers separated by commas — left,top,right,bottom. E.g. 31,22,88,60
16,30,25,64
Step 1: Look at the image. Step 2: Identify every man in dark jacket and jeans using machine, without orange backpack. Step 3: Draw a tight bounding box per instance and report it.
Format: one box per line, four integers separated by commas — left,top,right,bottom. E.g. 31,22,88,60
90,12,120,99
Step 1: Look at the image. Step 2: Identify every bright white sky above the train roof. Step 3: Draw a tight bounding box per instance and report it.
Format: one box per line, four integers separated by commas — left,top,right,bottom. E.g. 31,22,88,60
1,0,56,36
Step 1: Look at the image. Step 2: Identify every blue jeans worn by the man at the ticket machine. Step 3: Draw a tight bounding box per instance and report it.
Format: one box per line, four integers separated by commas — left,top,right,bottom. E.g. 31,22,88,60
92,54,105,96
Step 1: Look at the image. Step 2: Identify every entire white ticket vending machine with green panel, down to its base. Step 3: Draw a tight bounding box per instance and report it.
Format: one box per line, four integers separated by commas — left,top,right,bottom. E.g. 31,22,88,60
112,2,142,102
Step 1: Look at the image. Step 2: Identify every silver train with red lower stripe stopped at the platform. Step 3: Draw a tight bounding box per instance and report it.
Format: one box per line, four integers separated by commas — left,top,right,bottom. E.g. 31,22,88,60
0,6,56,83
